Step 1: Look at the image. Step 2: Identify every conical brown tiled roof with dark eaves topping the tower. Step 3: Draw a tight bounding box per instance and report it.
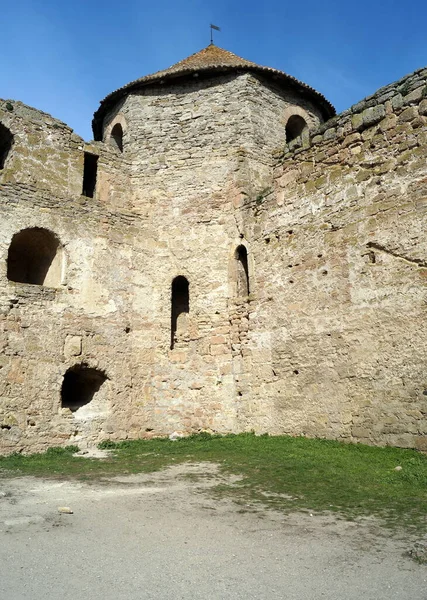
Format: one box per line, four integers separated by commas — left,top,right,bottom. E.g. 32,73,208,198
92,44,335,140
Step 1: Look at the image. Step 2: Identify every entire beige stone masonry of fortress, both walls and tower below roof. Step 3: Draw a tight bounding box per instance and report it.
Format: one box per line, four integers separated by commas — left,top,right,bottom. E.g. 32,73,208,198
0,49,427,452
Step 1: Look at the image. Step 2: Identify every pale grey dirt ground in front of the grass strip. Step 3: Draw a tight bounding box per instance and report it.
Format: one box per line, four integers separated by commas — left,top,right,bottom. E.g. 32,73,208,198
0,464,427,600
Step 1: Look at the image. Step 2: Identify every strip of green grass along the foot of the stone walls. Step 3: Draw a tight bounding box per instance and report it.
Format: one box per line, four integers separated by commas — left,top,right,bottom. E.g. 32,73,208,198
0,434,427,529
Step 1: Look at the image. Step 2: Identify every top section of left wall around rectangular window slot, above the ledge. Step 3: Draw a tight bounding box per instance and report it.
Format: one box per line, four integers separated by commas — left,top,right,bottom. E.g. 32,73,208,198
0,100,129,208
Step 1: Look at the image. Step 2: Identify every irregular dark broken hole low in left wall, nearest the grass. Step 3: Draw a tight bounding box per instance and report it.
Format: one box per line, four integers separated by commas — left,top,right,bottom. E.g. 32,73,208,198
61,364,107,412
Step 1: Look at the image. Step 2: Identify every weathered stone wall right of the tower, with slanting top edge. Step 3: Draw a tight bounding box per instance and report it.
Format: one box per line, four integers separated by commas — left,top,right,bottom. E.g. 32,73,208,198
246,69,427,449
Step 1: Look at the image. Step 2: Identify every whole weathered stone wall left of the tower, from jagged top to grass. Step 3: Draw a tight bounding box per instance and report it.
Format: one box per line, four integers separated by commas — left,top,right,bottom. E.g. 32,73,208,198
0,102,135,452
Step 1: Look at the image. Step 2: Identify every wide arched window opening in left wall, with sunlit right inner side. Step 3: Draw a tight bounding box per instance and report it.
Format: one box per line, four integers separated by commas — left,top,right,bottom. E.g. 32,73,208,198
7,227,63,287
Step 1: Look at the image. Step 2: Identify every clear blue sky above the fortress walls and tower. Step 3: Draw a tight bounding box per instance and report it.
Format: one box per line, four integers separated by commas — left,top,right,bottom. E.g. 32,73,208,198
0,0,427,140
